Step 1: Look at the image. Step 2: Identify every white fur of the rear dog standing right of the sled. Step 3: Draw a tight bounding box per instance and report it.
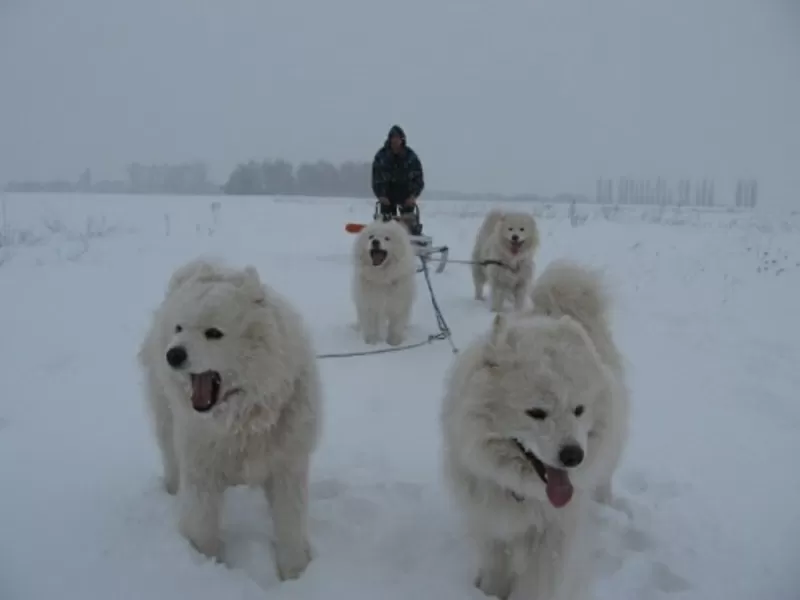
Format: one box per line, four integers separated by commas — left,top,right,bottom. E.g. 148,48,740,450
472,209,539,312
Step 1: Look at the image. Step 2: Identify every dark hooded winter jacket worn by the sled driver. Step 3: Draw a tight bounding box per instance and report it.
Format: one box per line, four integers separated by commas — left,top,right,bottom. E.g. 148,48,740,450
372,125,425,202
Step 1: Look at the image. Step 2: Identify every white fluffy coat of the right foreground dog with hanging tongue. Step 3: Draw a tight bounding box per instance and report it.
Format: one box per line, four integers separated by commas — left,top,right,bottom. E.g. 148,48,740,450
441,262,629,600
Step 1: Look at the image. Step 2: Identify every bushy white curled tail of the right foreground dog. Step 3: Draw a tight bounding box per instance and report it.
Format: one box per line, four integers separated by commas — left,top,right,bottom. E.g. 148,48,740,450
531,259,610,335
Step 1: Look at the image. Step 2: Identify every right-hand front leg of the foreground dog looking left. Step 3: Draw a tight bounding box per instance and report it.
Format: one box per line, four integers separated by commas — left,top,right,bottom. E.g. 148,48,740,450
264,460,311,580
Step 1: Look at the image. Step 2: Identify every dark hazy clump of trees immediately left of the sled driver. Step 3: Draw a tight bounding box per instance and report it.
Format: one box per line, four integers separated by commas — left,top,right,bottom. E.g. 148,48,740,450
222,159,372,198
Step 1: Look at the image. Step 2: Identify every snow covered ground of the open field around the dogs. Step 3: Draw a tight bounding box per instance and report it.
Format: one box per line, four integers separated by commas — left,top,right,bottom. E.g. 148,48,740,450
0,195,800,600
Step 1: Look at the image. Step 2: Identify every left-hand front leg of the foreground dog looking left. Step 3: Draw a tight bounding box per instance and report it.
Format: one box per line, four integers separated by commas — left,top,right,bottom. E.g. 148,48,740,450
178,474,224,561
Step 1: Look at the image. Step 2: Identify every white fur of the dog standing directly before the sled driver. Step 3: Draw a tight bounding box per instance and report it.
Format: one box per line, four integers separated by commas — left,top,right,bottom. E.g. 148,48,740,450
353,221,416,346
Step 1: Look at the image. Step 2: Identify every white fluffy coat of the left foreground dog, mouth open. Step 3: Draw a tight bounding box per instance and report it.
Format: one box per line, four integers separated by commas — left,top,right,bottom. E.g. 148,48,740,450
138,259,321,579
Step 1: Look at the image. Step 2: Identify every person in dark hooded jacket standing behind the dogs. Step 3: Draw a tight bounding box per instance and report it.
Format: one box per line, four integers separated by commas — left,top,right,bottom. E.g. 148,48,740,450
372,125,425,217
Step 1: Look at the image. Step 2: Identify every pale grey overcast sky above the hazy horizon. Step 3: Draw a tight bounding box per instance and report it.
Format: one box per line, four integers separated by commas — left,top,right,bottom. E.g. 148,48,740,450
0,0,800,204
